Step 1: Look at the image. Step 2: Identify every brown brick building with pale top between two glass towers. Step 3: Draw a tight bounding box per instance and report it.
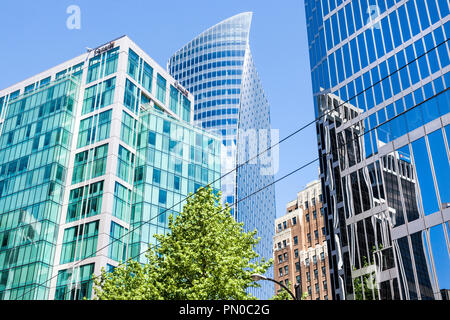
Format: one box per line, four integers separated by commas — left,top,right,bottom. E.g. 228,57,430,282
273,180,331,300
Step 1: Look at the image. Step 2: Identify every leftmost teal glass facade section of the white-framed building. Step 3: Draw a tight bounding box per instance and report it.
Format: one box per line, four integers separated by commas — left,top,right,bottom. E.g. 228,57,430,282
0,78,79,299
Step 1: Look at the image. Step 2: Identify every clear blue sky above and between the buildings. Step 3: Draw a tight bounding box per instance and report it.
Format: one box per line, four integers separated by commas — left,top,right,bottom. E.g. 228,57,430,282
0,0,318,216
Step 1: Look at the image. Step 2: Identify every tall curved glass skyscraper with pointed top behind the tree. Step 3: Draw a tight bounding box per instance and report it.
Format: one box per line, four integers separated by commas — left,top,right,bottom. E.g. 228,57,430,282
168,12,276,298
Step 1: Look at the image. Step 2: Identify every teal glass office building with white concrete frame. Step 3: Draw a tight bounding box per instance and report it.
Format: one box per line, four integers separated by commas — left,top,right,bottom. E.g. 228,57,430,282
0,36,221,299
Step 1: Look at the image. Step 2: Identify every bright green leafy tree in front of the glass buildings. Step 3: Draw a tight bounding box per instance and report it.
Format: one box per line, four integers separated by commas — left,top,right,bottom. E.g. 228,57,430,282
94,188,272,300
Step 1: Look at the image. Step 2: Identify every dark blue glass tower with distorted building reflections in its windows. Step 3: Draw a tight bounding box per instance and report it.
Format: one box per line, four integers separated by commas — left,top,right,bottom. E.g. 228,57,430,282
305,0,450,300
